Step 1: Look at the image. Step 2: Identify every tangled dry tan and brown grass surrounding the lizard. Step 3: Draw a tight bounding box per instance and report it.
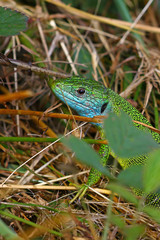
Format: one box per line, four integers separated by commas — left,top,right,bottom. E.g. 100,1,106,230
0,0,160,240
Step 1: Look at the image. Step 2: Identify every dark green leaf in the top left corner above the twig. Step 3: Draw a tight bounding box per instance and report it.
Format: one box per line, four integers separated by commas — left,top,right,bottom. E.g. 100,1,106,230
0,7,28,36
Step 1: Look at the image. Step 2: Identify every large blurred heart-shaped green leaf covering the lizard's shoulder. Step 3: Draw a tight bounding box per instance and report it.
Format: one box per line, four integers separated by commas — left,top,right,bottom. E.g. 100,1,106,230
104,112,159,158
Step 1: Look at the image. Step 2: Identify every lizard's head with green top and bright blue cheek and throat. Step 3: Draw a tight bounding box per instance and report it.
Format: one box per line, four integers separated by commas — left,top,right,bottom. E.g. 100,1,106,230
49,77,111,117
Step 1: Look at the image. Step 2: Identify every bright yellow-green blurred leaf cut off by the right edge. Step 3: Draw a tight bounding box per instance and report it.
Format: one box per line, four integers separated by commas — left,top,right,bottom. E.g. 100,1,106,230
143,150,160,193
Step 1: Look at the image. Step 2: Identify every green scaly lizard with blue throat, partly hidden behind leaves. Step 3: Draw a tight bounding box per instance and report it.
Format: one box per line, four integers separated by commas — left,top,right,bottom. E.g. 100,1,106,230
48,76,160,206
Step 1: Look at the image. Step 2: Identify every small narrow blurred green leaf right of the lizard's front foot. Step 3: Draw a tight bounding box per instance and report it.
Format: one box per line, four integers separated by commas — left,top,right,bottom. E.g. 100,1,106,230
107,183,138,205
